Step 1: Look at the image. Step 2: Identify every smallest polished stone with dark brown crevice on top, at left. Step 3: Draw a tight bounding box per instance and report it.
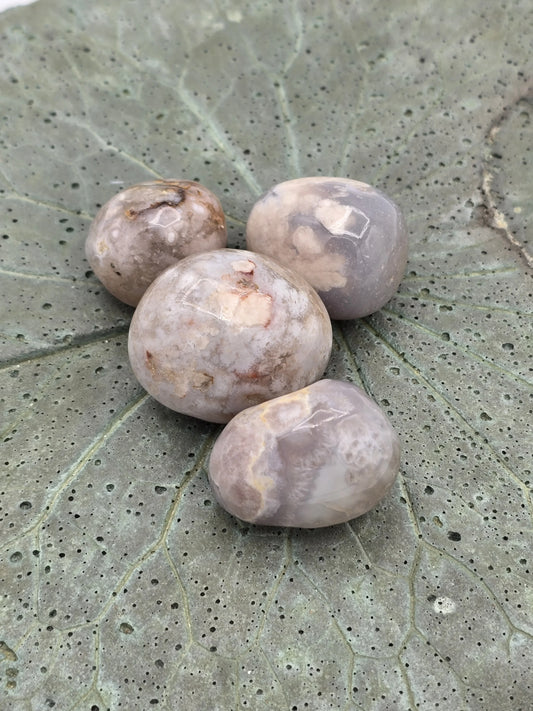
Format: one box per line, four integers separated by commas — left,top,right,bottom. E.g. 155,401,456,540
85,180,227,306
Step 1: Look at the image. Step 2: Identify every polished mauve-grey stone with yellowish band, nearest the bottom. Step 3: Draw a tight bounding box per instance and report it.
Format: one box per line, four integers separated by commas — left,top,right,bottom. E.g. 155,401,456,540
209,380,400,528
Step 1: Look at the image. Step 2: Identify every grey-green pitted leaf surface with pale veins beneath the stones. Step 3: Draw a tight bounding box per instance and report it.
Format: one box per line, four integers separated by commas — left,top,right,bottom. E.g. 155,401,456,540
0,0,533,711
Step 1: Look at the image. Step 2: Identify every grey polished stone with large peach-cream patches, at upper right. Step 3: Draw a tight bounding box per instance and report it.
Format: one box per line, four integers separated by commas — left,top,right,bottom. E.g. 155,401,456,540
246,177,407,319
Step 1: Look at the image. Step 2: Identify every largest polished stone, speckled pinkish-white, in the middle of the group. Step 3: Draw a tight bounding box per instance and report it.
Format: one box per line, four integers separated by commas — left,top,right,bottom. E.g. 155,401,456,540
128,249,332,422
